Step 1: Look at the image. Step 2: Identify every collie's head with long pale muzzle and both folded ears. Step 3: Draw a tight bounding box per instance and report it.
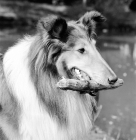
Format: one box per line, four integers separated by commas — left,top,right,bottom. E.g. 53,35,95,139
38,11,123,94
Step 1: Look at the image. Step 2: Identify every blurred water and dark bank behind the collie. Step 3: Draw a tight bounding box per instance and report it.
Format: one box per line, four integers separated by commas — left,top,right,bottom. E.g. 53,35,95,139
0,0,136,140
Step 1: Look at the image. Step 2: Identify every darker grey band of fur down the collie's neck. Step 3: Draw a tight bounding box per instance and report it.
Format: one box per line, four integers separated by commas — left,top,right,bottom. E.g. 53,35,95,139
29,36,67,125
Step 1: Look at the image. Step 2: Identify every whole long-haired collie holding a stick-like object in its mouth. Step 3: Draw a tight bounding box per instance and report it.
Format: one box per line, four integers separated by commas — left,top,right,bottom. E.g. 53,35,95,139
0,11,123,140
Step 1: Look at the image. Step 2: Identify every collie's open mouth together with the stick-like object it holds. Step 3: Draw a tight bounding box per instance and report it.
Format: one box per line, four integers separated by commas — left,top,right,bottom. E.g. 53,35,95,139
57,67,123,96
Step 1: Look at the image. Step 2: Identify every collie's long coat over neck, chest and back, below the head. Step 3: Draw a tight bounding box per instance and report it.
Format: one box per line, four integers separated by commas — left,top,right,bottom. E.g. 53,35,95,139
0,11,105,140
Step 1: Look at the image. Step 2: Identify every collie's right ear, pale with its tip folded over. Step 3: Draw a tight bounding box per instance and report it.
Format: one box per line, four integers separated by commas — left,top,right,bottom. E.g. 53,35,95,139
76,11,106,34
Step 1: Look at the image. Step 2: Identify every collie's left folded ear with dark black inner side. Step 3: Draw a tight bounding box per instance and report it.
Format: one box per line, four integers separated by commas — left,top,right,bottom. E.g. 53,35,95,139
38,15,67,39
